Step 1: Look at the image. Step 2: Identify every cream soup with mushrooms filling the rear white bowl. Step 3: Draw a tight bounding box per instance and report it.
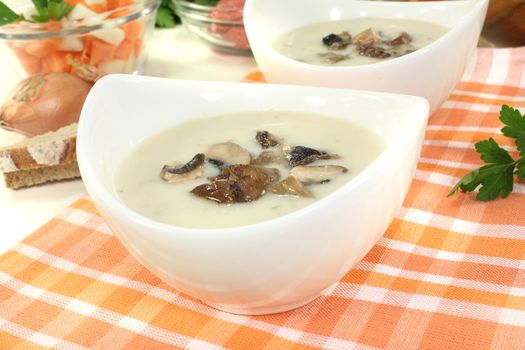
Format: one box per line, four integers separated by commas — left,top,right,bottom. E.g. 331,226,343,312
272,18,448,66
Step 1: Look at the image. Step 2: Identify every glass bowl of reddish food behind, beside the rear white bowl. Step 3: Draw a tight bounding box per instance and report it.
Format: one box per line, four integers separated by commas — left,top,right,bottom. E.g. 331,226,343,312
172,0,251,55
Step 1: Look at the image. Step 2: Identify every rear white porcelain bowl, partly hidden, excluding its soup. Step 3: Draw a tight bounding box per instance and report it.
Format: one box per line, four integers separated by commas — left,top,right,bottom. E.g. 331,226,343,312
244,0,488,112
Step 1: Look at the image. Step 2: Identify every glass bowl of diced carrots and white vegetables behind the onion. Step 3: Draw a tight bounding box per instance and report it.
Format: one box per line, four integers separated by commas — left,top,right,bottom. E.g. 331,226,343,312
0,0,160,80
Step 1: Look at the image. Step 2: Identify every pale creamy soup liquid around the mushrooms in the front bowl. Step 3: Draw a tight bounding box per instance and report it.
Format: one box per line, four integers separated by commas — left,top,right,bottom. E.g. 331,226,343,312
115,111,384,228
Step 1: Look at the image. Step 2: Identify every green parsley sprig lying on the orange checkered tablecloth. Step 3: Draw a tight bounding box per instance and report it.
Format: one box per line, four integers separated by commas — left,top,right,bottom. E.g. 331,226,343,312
448,105,525,201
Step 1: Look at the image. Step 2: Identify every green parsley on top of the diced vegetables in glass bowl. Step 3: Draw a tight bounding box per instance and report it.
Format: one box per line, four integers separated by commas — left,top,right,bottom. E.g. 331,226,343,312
0,0,74,26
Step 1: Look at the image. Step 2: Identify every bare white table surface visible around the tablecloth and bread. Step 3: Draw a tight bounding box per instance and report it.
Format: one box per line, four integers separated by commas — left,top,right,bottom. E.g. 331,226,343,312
0,27,256,254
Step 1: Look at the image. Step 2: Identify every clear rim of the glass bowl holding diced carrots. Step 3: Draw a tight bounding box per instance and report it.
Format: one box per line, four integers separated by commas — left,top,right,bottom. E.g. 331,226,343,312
0,0,160,40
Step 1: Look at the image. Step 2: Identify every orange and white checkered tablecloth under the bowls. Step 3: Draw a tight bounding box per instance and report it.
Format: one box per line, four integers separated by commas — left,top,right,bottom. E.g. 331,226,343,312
0,47,525,350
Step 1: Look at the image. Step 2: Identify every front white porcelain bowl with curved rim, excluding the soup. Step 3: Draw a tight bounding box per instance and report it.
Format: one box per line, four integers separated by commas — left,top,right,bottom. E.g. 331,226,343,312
77,75,428,314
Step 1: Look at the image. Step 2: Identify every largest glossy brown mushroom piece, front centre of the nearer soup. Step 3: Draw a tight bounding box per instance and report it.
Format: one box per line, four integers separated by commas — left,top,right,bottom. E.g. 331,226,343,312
191,164,276,203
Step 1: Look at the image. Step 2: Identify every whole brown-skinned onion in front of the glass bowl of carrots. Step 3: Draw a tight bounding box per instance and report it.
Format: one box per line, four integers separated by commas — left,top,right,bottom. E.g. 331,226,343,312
0,73,92,135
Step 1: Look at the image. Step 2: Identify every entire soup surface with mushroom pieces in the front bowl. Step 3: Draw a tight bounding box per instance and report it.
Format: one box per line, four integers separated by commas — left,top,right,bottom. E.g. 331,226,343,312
115,111,384,228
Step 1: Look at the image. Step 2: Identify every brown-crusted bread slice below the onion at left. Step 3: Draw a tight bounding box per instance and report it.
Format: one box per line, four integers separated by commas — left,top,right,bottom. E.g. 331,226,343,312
0,123,80,189
